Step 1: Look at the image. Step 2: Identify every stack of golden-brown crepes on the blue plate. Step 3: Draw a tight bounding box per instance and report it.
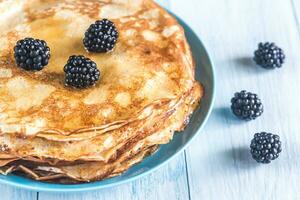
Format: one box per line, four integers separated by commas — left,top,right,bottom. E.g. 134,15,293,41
0,0,203,183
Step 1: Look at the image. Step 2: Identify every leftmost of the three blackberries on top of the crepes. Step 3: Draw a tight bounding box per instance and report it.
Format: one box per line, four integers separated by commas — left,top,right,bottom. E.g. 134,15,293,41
14,38,50,71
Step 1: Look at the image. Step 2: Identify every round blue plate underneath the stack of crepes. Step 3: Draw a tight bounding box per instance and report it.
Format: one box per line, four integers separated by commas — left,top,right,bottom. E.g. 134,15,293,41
0,12,215,192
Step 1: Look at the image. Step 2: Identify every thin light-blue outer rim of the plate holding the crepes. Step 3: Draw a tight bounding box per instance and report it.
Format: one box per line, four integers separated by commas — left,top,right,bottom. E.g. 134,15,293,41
0,8,216,193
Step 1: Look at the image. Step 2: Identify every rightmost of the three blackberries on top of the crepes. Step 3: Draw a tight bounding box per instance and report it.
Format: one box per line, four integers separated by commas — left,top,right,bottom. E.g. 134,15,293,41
83,19,119,53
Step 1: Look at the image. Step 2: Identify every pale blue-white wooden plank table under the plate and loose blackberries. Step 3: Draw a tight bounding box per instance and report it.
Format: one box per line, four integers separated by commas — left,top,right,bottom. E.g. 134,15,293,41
0,0,300,200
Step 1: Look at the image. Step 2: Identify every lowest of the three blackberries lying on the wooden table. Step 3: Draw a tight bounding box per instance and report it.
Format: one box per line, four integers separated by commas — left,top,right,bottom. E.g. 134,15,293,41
250,132,281,164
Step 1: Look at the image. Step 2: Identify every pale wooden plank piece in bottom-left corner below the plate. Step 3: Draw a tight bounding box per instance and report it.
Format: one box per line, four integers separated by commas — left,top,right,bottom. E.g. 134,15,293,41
0,184,37,200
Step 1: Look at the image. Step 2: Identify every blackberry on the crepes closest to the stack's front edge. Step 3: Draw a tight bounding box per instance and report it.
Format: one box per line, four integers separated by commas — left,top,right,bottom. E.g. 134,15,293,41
64,55,100,88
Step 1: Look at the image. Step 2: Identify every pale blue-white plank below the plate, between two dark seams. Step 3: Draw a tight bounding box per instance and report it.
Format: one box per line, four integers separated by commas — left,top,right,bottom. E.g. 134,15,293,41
39,154,188,200
